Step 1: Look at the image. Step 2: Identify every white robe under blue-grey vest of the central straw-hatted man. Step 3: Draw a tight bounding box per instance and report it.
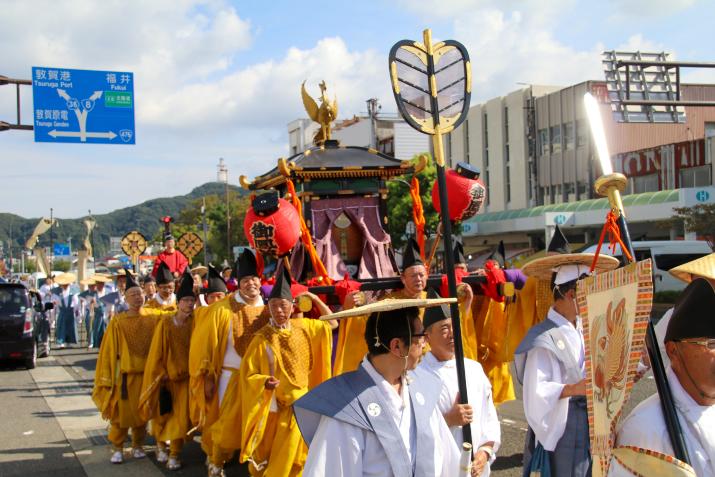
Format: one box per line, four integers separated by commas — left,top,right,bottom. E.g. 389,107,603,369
303,357,459,477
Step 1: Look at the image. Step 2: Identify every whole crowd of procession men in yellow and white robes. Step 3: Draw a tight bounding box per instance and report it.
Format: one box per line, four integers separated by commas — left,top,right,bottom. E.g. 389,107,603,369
85,231,715,477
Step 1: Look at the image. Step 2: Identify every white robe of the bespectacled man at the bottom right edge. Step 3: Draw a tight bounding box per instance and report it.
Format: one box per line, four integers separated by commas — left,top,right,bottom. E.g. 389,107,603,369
608,367,715,477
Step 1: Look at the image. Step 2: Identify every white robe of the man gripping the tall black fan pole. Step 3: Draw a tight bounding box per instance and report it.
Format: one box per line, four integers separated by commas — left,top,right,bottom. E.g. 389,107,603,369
418,352,501,476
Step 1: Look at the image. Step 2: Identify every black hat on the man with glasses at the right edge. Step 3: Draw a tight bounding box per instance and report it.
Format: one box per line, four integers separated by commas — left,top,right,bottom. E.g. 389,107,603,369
664,278,715,341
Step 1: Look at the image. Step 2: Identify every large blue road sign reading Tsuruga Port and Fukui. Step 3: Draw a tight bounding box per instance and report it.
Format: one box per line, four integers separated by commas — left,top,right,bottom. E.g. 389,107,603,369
32,66,136,144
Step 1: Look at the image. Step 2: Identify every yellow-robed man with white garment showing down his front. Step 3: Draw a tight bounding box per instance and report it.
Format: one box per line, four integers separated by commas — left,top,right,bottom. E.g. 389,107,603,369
189,249,269,476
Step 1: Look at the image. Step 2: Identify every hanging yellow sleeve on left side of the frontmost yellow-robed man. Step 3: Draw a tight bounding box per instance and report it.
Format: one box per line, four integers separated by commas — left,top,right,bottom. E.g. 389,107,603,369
239,336,273,462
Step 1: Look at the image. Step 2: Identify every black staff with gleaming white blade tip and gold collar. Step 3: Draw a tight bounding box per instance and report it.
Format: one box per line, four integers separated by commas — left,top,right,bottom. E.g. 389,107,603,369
584,93,690,464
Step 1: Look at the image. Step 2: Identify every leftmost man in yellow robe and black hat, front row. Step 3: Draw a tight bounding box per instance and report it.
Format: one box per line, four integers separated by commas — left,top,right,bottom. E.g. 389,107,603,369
92,273,170,464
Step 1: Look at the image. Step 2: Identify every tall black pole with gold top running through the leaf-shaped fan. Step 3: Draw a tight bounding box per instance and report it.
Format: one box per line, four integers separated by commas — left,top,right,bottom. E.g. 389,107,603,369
424,30,472,444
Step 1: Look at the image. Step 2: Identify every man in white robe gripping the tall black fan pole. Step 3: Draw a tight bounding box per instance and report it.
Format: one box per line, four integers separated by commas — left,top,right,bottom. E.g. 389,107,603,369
417,288,501,477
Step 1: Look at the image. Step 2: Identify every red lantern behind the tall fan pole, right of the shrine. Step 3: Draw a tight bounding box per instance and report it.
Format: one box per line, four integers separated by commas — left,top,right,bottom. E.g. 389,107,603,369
432,162,487,222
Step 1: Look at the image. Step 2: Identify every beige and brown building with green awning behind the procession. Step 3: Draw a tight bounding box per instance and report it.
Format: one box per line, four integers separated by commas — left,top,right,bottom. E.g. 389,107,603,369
445,81,715,253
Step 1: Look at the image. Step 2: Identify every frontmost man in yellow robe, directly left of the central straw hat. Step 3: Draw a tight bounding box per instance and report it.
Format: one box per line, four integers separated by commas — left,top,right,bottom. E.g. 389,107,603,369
239,267,332,477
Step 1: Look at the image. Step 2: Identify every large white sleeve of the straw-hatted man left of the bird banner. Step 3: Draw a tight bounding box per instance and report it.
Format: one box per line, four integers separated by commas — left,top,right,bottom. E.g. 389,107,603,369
524,348,569,451
